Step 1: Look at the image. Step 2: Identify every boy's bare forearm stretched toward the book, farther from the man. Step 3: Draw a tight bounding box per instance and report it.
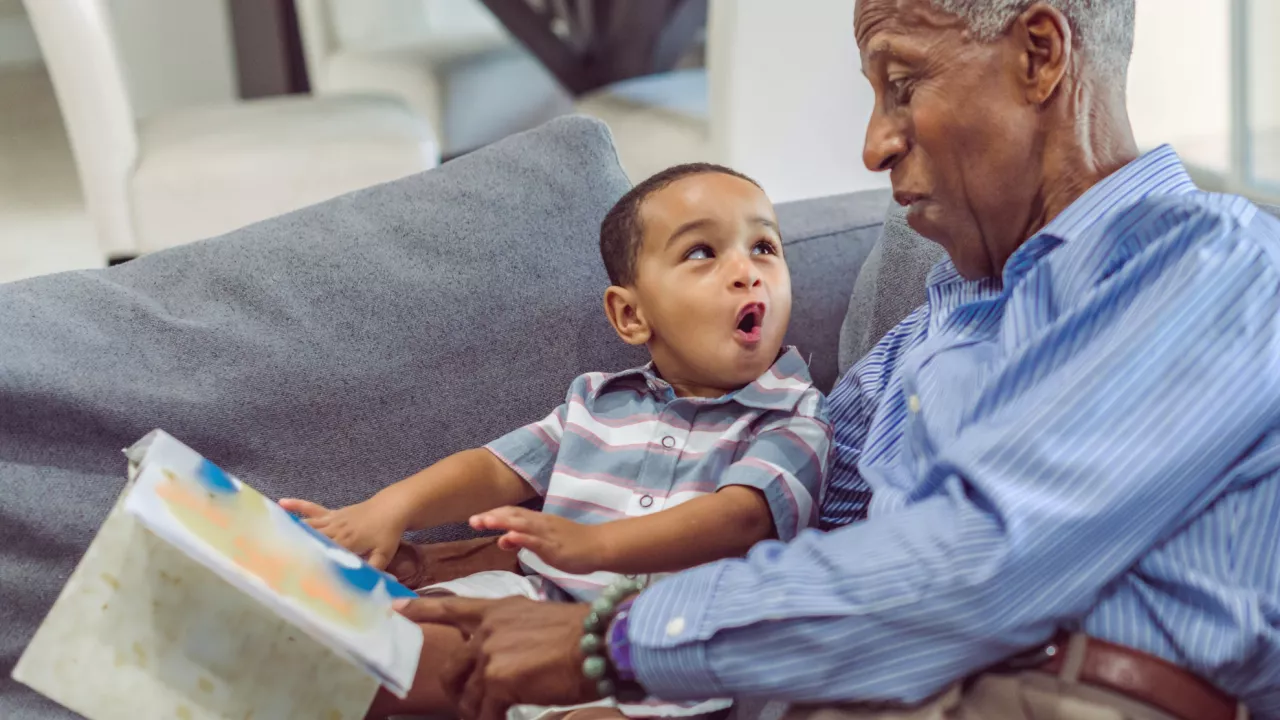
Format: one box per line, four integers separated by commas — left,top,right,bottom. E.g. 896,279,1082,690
374,448,538,530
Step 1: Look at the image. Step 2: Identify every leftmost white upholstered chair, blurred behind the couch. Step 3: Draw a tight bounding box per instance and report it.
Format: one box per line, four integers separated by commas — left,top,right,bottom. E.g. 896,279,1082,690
26,0,439,258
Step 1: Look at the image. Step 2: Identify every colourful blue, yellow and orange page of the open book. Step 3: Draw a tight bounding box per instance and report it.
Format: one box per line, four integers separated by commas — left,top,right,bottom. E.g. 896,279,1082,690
125,430,422,697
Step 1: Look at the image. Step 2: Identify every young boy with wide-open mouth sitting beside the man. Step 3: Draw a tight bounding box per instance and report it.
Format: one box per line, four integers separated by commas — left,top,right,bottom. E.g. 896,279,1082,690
282,164,831,716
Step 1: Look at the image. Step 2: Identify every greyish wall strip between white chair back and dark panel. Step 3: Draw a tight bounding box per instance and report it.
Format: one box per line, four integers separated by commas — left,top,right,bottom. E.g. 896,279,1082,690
106,0,238,118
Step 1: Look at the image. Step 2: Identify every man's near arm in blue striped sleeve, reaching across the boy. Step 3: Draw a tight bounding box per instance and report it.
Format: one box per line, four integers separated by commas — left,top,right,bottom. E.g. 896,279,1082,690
628,207,1280,702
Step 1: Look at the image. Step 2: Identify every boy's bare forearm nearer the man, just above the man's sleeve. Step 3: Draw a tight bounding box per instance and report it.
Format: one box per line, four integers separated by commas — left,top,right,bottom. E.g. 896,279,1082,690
588,486,773,574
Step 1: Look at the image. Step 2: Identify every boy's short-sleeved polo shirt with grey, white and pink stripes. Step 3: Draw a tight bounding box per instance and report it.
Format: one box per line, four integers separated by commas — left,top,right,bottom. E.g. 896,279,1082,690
486,347,831,601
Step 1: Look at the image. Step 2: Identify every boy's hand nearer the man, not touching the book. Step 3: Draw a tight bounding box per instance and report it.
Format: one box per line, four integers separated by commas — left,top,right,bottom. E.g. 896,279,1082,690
471,507,608,574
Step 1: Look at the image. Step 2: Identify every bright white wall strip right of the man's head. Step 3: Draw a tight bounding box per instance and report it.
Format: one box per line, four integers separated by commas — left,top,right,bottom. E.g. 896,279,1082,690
1128,0,1233,170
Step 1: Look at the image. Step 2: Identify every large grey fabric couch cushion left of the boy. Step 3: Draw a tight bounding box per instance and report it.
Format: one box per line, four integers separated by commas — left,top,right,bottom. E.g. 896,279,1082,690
0,118,643,717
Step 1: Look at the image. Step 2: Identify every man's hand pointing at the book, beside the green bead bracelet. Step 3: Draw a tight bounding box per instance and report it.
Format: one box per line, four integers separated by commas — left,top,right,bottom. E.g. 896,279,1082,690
397,597,599,720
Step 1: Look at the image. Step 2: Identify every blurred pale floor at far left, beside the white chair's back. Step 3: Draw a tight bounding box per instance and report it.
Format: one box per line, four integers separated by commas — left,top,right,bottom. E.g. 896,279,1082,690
0,68,104,282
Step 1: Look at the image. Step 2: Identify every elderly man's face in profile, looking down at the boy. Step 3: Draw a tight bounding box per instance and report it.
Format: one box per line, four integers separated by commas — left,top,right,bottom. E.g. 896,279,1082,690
854,0,1039,279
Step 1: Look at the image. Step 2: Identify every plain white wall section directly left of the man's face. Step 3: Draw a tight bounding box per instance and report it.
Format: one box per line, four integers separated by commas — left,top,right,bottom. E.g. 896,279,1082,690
707,0,888,202
